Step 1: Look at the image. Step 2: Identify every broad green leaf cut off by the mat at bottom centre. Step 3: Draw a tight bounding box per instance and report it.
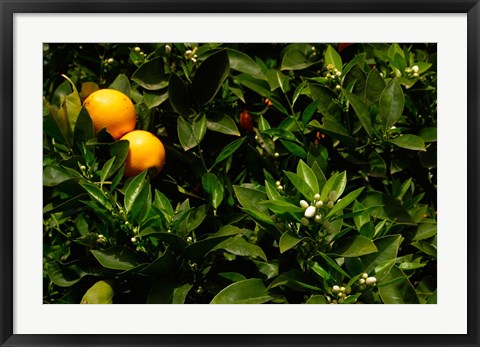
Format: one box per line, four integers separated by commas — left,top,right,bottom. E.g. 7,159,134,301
210,278,274,304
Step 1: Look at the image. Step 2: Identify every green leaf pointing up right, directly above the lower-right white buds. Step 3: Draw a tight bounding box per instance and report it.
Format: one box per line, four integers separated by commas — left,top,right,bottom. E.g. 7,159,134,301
362,235,403,280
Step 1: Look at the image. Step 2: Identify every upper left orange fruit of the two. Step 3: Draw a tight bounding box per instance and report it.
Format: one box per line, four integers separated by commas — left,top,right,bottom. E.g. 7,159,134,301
83,89,136,140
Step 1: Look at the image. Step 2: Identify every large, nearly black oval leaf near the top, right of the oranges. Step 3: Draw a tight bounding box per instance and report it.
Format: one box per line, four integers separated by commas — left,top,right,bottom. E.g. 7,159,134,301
192,50,230,105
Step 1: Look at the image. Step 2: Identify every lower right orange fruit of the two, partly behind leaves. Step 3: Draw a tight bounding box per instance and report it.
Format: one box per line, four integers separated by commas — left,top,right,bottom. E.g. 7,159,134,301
121,130,165,177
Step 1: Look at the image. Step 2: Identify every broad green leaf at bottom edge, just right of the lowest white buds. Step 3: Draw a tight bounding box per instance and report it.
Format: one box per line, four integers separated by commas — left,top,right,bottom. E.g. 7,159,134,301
378,266,419,304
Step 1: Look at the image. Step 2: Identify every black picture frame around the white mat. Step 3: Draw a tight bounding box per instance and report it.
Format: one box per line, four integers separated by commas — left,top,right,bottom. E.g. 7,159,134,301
0,0,480,346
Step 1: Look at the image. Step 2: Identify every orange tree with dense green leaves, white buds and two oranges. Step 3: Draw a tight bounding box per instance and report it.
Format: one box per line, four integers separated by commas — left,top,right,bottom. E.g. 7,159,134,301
43,43,437,304
